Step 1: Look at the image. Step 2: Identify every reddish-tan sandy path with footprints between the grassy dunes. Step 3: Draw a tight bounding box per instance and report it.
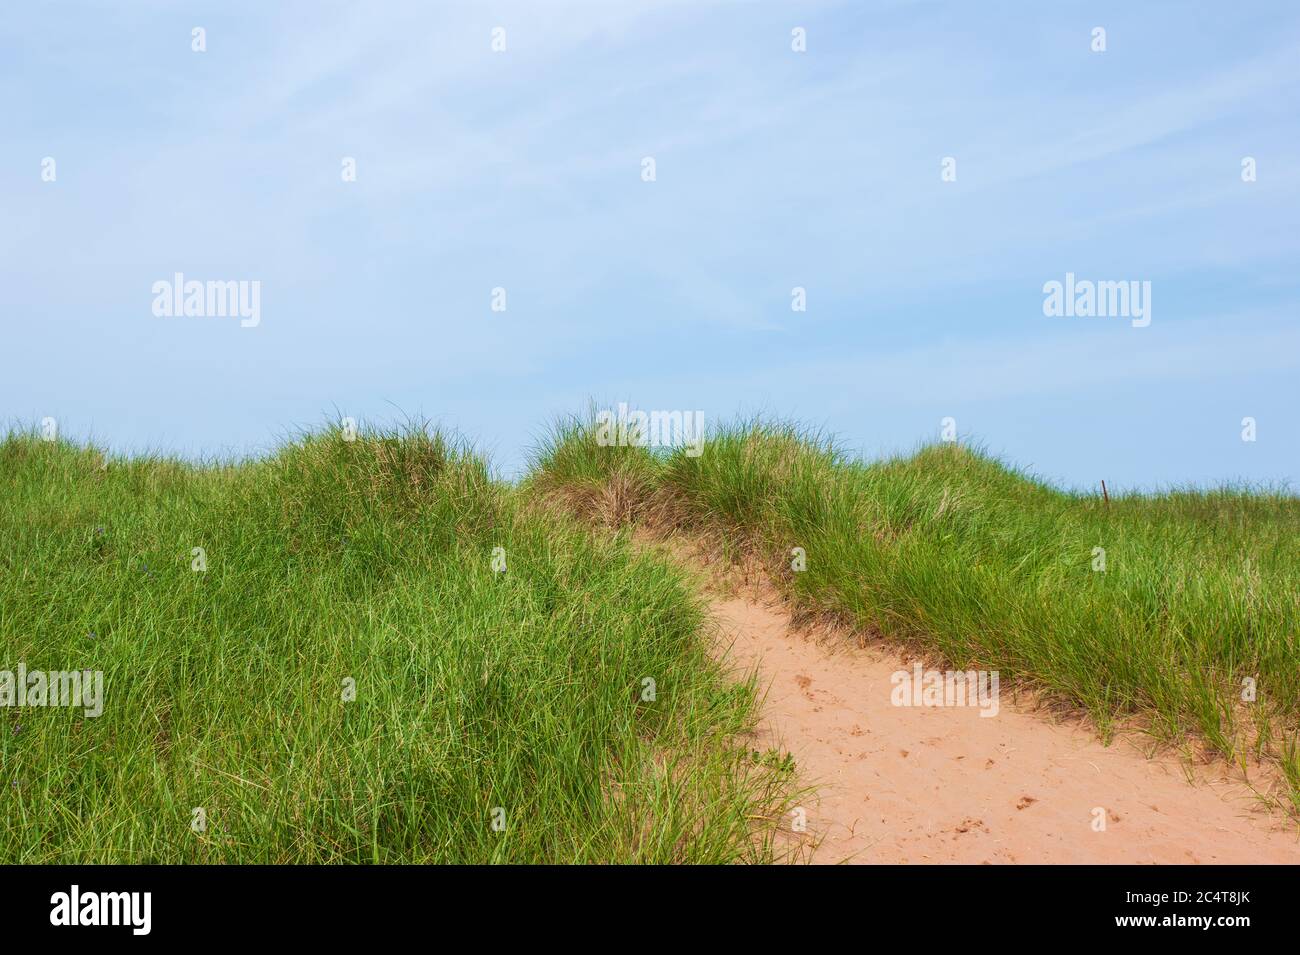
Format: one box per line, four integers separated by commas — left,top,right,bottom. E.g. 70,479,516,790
714,596,1300,863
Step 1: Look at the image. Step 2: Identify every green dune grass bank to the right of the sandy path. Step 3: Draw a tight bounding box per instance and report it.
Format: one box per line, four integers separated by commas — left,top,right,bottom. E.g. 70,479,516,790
530,418,1300,804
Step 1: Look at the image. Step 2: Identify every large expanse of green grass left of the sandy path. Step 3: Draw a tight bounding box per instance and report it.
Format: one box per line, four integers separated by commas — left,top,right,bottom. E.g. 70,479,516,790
0,427,792,863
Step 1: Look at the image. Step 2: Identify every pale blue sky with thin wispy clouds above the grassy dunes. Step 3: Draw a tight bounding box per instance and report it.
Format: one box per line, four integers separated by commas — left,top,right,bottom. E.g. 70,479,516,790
0,0,1300,489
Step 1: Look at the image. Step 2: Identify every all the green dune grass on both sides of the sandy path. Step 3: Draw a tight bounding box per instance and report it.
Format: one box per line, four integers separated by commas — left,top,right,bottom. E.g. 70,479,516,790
0,407,1300,863
